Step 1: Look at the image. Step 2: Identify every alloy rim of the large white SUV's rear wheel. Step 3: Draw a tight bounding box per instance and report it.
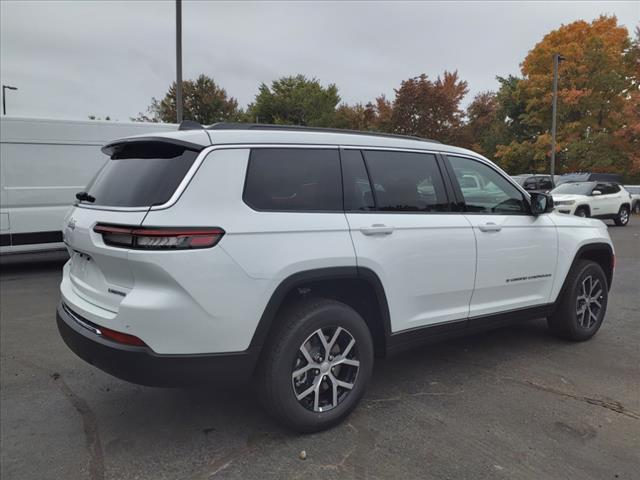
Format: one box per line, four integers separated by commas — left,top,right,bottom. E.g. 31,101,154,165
291,327,360,412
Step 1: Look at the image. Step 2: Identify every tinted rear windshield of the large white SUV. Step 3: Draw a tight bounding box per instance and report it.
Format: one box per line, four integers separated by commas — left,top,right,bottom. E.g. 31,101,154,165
81,142,198,207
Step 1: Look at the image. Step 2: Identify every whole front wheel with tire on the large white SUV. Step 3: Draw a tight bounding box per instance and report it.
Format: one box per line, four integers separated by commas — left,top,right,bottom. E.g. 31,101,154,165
547,260,608,342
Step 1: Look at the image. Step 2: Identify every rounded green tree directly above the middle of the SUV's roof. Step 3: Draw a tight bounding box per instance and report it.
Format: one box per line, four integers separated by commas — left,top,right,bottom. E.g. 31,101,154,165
247,75,340,127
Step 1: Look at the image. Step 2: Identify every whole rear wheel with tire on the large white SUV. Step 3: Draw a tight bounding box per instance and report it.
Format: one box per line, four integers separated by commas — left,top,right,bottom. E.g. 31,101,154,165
258,299,374,433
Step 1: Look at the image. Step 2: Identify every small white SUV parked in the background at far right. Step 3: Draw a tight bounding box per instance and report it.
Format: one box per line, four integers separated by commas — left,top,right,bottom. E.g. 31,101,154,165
551,182,631,226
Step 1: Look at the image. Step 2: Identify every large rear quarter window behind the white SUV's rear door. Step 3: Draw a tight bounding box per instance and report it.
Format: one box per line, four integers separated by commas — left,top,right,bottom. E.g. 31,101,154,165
242,148,342,212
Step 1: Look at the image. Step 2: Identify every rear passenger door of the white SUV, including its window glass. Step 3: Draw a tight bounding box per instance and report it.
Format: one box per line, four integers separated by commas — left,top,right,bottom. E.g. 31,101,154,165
341,148,476,333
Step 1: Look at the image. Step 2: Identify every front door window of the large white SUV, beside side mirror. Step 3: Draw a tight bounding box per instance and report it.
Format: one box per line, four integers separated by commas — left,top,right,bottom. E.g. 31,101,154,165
447,156,528,215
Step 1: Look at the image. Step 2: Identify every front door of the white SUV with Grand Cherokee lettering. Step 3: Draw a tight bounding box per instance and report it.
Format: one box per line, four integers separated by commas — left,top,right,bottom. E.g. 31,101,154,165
447,155,558,320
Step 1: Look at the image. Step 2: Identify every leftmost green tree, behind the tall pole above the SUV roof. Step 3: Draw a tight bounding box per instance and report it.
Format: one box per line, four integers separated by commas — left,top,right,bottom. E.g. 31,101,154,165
132,75,243,125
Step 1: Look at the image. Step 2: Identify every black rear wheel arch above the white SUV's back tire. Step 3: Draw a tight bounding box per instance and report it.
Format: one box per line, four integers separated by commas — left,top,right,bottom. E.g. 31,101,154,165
250,266,391,356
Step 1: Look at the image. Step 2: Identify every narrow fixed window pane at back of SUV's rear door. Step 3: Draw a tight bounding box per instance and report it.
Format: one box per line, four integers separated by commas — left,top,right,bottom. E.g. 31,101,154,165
341,150,375,212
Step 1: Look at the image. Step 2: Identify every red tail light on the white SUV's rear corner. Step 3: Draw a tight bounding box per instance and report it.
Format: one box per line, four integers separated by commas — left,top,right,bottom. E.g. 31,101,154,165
93,224,224,250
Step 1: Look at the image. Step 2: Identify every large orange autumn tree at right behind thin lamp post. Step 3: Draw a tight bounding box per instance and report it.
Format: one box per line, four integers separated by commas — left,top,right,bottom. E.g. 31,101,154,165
495,16,640,179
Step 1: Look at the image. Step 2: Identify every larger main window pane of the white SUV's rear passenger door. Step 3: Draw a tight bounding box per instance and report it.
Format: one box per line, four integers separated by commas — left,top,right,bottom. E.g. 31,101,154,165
363,150,449,212
